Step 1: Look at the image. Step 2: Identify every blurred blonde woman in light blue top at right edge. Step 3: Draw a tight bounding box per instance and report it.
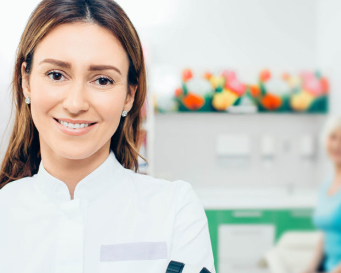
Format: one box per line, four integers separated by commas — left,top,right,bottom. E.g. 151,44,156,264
306,117,341,273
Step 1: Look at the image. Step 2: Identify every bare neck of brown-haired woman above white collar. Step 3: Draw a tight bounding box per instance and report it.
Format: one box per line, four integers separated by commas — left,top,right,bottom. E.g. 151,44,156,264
41,145,109,199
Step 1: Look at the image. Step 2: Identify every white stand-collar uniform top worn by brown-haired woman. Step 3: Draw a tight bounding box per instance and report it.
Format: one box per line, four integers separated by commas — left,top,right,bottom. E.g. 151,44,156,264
0,152,215,273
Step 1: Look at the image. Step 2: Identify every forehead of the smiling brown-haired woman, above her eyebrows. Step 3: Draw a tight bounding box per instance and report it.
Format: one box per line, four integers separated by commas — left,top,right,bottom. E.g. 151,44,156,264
34,22,129,71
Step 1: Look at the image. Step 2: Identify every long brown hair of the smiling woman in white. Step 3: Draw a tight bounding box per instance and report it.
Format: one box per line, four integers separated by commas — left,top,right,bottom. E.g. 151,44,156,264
0,0,147,188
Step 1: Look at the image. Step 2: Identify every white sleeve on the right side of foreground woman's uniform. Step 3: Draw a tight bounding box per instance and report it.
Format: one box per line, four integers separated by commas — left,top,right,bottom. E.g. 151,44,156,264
170,178,215,273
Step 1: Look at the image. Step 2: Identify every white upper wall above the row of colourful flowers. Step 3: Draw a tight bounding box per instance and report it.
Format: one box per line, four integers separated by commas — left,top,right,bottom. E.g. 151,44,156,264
133,0,317,69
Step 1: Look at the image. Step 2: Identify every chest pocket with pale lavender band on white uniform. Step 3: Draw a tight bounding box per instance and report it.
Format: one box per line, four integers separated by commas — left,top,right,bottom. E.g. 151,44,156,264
100,242,167,273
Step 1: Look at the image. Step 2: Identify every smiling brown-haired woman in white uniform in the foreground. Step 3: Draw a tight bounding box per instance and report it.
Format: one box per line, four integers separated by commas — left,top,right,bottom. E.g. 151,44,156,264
0,0,215,273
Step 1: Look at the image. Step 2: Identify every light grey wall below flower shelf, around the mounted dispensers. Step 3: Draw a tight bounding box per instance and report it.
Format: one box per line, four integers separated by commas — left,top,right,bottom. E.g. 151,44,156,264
154,113,327,188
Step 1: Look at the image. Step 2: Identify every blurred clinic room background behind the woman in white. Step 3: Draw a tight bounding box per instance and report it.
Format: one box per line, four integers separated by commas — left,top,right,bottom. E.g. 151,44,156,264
0,0,341,273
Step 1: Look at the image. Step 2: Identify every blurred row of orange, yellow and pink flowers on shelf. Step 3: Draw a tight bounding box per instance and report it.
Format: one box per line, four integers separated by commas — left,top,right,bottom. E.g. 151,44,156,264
155,69,329,113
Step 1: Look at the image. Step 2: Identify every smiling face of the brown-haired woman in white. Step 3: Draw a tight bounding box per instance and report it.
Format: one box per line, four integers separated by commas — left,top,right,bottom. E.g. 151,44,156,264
22,22,135,159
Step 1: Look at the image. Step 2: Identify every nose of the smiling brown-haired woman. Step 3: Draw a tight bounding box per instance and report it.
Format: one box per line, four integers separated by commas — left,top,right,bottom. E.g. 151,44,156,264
63,81,90,114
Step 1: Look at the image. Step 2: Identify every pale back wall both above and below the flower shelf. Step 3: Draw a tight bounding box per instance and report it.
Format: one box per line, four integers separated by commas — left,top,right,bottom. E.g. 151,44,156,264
140,0,326,187
